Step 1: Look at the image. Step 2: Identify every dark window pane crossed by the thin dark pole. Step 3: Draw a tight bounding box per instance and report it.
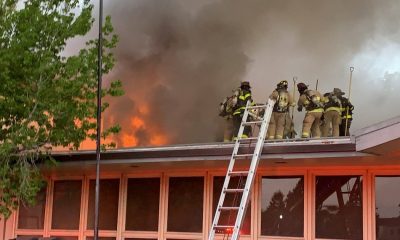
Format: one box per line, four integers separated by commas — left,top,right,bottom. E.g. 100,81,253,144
87,179,119,230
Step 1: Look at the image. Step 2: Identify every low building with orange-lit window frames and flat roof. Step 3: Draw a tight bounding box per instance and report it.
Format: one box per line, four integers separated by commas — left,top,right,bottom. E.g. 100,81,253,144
0,117,400,240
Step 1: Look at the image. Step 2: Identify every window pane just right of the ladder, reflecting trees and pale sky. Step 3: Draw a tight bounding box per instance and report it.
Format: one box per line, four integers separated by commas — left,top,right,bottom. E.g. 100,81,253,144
261,176,304,237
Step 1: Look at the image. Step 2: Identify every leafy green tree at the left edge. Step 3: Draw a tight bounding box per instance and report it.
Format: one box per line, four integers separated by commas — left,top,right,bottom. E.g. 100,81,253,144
0,0,123,218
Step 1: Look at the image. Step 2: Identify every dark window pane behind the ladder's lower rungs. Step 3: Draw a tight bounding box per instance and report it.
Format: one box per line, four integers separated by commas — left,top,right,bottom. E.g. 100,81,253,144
213,177,251,235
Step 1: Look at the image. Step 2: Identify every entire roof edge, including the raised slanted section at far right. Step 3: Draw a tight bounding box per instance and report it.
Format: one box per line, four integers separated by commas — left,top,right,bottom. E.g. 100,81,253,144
52,116,400,167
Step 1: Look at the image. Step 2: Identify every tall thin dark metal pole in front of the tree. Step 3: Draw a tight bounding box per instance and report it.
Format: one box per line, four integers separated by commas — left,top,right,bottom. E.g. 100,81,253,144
94,0,103,240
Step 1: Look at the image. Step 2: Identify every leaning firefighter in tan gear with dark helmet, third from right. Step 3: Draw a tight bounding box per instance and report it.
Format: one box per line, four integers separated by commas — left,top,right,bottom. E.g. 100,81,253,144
297,83,324,138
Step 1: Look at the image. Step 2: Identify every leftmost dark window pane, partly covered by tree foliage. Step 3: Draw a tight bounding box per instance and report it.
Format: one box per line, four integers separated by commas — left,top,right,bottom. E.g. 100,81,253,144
18,187,46,229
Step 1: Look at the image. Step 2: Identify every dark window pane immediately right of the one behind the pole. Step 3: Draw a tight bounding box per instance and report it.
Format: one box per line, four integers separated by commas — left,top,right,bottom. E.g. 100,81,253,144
125,178,160,231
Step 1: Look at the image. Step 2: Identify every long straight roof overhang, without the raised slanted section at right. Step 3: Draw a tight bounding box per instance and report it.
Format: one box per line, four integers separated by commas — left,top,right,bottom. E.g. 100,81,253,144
53,137,358,165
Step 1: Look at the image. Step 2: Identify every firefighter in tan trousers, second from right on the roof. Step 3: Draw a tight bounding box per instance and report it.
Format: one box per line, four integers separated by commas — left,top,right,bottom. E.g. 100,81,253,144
322,88,344,137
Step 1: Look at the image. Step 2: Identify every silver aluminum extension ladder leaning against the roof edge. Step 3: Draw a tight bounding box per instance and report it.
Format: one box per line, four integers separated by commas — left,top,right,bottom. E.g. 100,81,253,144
208,99,275,240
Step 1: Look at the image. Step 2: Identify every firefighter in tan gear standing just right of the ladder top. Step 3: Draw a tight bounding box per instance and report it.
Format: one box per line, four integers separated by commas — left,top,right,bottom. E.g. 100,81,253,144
267,80,294,139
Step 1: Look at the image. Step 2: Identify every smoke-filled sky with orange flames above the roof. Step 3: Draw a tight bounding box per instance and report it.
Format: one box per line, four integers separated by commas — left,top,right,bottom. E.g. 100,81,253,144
67,0,400,147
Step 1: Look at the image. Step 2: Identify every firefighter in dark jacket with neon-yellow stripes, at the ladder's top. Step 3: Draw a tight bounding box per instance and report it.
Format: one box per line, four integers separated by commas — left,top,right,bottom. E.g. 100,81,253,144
233,81,254,140
